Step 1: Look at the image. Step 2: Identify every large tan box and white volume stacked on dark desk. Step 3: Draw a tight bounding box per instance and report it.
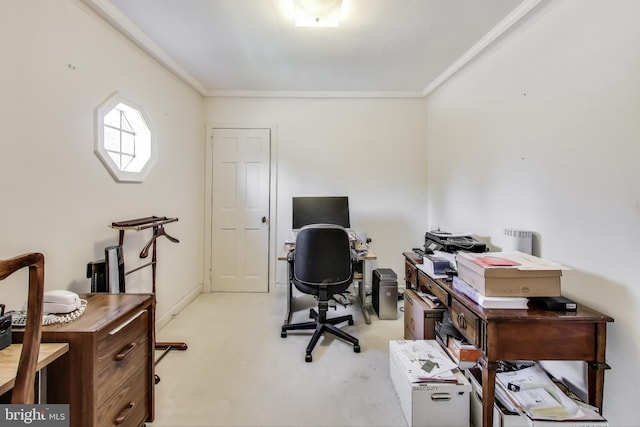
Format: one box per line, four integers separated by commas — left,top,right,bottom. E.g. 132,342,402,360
453,252,566,309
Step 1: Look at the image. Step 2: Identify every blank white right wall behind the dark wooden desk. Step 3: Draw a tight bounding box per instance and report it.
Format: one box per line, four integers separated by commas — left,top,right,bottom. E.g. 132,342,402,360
427,0,640,426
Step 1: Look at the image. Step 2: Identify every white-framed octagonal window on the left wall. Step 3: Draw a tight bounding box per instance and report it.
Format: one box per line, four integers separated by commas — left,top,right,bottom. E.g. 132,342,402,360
95,94,156,182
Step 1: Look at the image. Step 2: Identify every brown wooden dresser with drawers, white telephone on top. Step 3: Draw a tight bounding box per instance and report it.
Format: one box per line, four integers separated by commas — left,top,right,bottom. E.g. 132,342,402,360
13,293,155,427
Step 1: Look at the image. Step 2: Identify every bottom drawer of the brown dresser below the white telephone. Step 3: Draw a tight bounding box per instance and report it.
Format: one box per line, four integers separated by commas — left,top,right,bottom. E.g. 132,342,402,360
97,370,149,427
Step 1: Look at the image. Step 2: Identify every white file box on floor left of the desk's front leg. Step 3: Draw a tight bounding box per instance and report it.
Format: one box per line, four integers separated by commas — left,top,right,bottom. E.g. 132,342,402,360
389,341,471,427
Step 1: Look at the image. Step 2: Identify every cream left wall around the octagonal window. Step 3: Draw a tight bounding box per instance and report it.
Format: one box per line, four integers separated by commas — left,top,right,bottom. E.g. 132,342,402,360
0,0,205,320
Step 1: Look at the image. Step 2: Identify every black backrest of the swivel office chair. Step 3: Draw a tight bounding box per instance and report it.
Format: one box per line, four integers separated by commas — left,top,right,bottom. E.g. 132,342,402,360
293,224,353,286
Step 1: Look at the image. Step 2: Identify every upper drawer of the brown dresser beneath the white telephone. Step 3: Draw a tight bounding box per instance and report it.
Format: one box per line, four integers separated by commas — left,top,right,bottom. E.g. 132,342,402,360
96,310,150,402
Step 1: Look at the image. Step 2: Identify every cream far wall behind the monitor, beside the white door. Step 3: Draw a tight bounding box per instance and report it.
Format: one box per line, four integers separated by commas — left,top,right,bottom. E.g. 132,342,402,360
206,98,427,285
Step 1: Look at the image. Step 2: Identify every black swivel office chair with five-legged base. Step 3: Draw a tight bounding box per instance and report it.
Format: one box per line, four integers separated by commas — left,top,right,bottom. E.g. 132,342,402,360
280,224,360,362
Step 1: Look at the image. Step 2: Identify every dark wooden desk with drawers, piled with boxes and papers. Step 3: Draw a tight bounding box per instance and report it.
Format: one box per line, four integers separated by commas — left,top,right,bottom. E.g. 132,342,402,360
403,252,613,427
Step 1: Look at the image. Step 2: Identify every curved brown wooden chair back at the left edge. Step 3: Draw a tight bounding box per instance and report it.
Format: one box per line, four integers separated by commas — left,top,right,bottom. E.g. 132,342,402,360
0,253,44,404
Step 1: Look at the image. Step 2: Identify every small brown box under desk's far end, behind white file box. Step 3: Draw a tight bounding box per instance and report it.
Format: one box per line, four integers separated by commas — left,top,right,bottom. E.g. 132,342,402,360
404,289,446,340
